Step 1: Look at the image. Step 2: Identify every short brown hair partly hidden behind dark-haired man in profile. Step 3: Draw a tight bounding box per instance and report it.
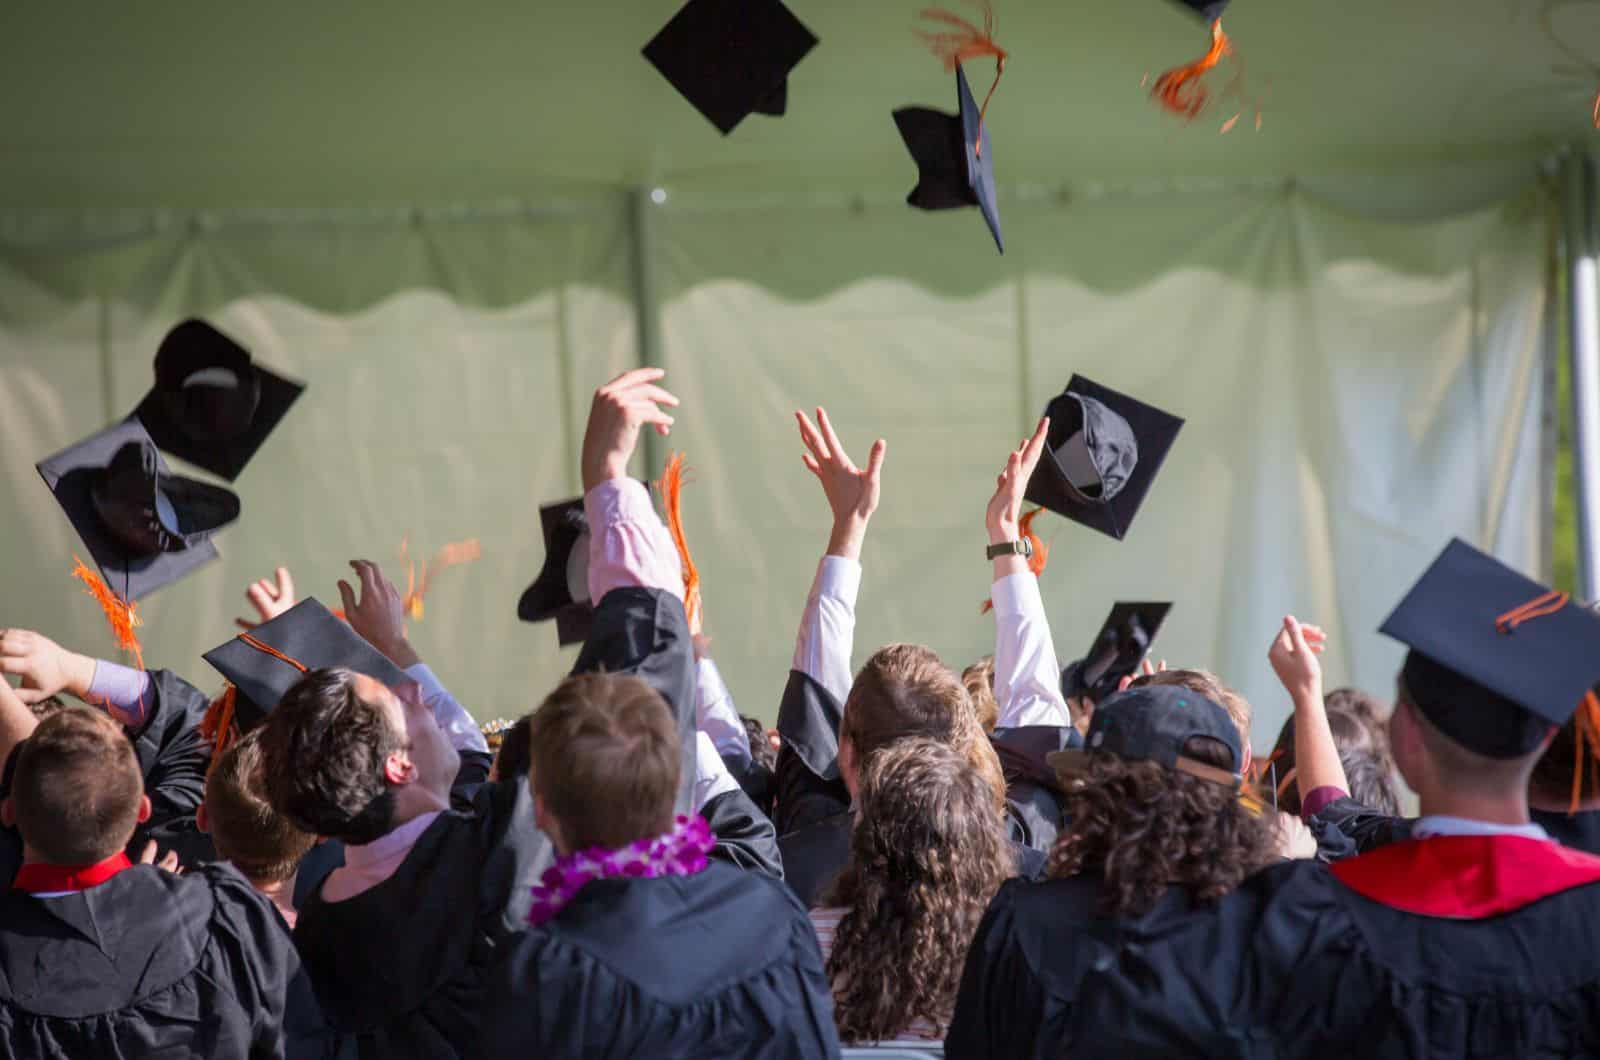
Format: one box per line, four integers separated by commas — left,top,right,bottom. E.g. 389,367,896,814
205,729,317,884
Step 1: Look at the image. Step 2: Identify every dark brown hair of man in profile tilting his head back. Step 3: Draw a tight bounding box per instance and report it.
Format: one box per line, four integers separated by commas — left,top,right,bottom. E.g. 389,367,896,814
261,669,405,845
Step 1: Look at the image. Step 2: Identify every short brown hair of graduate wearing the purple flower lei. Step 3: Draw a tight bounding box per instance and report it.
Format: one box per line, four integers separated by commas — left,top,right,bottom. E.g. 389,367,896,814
528,674,683,850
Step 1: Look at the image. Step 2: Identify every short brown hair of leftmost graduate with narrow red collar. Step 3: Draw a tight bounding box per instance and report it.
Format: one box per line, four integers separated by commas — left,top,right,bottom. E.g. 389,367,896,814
11,706,144,865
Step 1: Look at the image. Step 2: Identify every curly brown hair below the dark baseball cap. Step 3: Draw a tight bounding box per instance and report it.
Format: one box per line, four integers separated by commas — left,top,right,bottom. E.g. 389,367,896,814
1050,737,1277,916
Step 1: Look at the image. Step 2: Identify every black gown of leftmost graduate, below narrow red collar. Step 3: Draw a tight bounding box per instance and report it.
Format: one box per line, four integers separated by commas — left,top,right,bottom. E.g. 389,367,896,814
0,865,314,1060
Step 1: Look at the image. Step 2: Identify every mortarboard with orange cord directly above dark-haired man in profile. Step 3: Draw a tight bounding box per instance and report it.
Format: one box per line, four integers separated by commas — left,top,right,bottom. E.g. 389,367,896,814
203,597,411,730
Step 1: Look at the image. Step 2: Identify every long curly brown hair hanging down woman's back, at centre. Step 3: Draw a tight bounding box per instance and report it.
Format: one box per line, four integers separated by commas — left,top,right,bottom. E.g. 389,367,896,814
826,737,1011,1042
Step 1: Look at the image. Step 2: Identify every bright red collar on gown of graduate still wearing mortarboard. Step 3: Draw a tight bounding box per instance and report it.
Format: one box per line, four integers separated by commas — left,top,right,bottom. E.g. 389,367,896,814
1333,836,1600,921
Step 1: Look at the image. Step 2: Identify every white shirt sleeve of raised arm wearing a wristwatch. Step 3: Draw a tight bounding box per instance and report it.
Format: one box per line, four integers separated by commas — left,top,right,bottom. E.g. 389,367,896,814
992,572,1072,729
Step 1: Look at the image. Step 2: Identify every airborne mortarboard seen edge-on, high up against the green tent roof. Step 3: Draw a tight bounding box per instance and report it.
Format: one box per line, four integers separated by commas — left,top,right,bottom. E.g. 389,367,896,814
894,66,1005,253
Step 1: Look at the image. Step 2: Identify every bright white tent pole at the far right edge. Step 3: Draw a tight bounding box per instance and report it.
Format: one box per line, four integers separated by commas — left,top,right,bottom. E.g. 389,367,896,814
1563,147,1600,600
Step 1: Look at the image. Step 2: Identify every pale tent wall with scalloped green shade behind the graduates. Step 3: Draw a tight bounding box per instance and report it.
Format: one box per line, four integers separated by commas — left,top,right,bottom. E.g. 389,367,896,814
0,184,1550,745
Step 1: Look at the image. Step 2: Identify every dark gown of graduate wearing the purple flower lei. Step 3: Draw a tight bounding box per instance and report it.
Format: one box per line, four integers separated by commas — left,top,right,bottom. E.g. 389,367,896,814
478,861,838,1060
